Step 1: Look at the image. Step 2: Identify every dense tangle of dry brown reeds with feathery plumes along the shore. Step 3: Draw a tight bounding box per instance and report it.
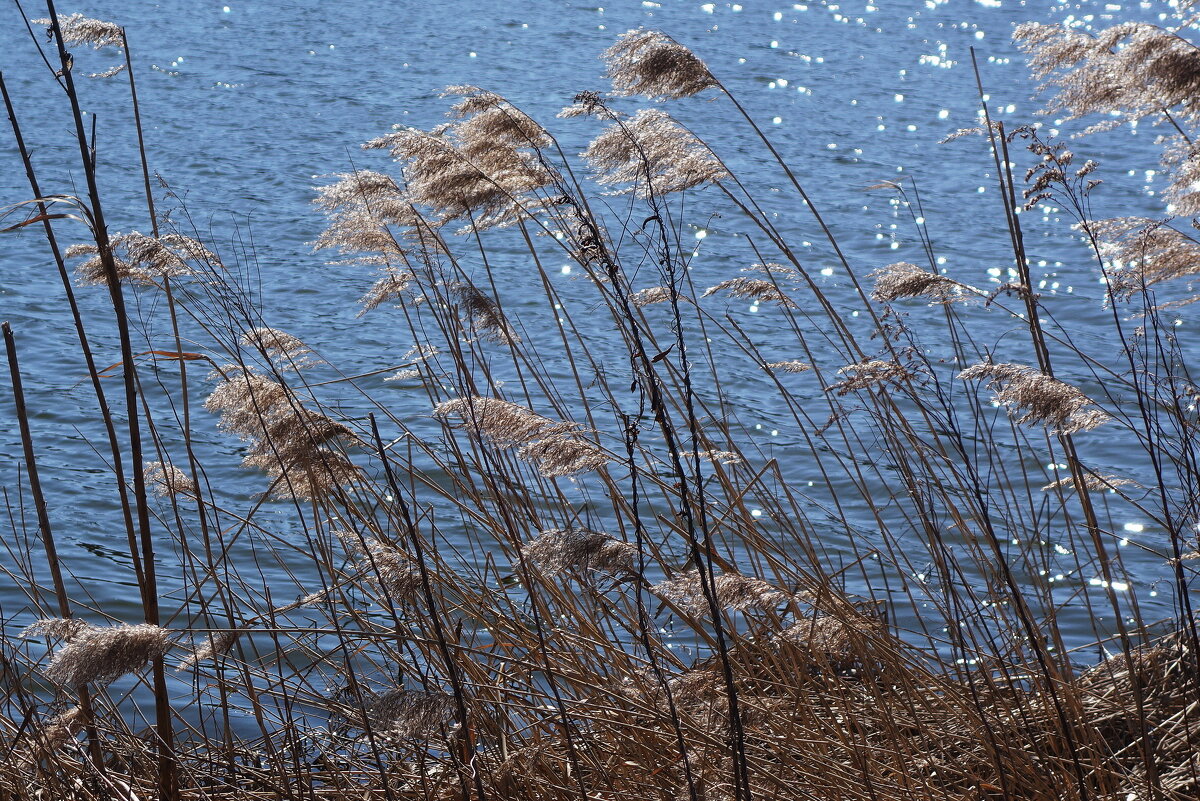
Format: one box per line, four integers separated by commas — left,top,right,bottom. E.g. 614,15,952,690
0,2,1200,801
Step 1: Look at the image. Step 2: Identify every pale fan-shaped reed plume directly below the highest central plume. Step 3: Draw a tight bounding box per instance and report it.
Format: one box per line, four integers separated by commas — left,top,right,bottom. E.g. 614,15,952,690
583,108,728,197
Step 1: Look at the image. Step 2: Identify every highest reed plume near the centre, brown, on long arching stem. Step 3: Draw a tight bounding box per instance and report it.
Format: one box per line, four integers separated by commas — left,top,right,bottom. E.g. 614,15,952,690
600,28,718,97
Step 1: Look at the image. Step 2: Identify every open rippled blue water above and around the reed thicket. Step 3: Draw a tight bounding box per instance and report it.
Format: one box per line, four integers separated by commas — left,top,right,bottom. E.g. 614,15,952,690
0,0,1193,681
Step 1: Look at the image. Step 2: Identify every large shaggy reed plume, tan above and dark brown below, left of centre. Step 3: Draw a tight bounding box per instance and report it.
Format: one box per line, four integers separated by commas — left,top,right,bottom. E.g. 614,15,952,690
204,365,359,499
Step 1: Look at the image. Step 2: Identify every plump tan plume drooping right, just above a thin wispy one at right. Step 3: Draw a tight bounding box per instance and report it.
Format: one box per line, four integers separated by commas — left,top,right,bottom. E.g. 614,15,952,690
959,362,1110,434
